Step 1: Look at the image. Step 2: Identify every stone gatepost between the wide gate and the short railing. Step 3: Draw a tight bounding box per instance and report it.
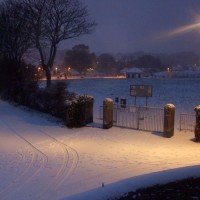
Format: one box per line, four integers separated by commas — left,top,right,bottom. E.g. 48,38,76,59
164,104,175,138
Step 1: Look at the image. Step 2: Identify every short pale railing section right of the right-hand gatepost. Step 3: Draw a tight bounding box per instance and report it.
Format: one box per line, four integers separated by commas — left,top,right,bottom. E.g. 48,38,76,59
180,113,196,131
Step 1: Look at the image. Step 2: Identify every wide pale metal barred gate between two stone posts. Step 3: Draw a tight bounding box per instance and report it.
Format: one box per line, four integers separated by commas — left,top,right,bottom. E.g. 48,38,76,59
100,105,164,132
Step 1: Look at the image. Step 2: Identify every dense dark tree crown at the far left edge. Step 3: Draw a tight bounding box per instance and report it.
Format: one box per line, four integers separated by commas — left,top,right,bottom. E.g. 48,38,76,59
0,0,33,67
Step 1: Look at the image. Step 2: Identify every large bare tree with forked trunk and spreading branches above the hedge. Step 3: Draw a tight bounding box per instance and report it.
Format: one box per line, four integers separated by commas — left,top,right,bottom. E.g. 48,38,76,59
23,0,95,87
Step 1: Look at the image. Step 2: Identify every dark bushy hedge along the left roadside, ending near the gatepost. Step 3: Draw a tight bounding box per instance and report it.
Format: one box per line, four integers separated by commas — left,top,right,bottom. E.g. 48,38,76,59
1,82,93,127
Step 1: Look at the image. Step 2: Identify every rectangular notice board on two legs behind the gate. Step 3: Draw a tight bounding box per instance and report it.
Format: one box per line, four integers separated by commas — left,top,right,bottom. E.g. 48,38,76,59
130,85,152,107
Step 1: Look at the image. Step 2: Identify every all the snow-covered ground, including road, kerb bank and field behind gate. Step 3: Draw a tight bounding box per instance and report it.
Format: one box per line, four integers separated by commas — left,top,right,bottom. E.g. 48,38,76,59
0,79,200,200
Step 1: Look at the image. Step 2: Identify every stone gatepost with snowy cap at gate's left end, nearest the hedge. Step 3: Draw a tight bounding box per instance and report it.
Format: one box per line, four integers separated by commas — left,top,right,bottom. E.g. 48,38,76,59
103,98,113,129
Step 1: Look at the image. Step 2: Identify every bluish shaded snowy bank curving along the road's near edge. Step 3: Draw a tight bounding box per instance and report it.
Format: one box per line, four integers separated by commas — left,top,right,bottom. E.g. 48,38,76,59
62,165,200,200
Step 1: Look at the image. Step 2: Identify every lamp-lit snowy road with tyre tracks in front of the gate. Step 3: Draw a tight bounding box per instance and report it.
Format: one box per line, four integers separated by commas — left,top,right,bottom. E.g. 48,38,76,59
0,101,200,200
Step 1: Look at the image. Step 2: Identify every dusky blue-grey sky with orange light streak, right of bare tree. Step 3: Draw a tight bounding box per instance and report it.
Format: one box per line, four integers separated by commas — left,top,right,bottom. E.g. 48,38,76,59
62,0,200,53
